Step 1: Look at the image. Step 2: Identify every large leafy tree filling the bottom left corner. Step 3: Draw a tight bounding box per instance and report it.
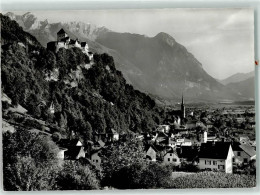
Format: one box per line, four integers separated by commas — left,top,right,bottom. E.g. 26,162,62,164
3,130,59,191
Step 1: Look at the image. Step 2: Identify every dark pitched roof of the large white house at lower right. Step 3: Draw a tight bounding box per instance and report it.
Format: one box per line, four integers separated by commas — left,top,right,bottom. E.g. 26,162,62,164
199,142,231,159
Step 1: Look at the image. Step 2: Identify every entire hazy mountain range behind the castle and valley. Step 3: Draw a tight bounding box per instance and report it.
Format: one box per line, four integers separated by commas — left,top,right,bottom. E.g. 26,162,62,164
6,12,254,102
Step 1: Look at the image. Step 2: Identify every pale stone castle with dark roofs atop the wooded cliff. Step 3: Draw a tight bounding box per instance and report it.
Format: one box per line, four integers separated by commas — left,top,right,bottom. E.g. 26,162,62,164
47,29,93,60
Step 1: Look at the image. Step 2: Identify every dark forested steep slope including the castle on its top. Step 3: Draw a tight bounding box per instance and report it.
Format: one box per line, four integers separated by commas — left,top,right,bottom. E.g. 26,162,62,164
0,14,165,140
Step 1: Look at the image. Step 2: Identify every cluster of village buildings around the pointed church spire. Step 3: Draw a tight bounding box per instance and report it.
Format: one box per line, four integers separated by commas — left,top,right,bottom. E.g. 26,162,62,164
141,97,256,173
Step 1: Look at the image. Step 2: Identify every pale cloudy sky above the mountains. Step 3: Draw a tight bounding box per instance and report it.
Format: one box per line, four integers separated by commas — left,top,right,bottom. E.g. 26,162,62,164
5,8,254,79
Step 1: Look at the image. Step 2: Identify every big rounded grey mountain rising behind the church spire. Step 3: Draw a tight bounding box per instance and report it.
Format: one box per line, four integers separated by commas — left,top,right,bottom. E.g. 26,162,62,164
96,32,238,101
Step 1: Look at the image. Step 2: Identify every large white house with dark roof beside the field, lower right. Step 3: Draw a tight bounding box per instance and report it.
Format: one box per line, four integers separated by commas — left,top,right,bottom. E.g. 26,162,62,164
198,142,234,173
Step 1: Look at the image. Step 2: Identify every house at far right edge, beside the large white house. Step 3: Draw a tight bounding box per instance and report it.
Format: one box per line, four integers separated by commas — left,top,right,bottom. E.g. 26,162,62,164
231,142,256,164
